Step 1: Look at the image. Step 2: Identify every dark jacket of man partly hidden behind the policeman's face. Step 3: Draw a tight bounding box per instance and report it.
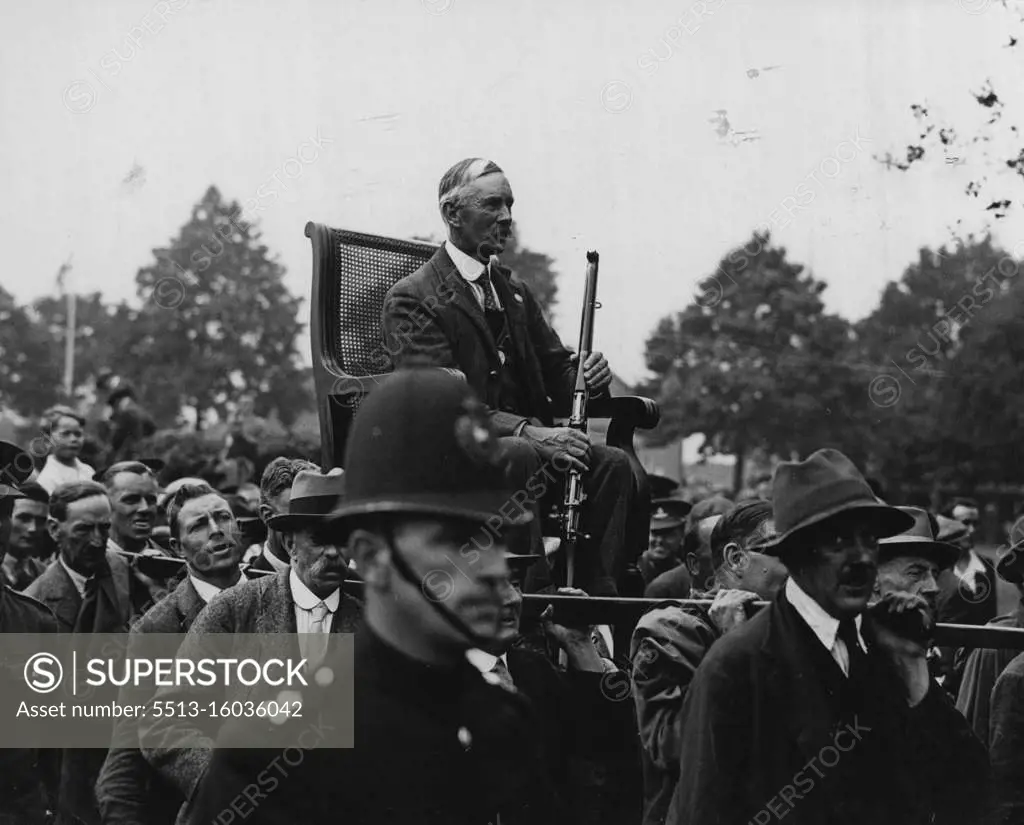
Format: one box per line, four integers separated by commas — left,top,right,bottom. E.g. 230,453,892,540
507,646,640,825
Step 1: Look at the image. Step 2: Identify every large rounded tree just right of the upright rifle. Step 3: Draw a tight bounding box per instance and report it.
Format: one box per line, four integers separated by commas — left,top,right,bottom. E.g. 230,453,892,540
642,229,866,491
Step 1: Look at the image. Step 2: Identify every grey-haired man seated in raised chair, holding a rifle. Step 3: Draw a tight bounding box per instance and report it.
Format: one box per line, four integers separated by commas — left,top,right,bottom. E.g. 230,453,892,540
383,158,636,596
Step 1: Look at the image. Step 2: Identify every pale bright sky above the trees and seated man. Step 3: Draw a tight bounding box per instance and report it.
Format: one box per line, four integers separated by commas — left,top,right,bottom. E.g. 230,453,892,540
0,0,1024,381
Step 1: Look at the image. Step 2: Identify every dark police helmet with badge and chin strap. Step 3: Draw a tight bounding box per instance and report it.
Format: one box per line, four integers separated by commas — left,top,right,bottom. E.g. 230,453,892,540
334,368,532,527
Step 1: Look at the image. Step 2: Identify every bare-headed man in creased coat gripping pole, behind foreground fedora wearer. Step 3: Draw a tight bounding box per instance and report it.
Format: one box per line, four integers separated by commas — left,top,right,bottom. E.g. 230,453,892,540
630,501,786,825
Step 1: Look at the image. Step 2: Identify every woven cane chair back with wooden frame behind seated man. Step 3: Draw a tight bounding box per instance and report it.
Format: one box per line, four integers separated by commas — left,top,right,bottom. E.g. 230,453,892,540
306,222,437,469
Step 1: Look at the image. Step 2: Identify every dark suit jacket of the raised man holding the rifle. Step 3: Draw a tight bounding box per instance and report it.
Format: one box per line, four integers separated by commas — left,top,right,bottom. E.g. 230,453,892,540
383,246,575,436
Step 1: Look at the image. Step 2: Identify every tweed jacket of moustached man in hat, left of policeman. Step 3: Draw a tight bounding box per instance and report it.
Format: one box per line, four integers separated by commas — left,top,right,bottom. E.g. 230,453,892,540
139,570,361,799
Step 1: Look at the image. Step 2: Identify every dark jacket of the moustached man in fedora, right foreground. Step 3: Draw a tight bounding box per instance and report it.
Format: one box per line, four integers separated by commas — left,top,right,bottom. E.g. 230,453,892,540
667,592,988,825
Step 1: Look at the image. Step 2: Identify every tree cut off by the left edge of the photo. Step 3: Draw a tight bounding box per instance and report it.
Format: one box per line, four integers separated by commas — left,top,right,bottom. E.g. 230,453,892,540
0,287,63,416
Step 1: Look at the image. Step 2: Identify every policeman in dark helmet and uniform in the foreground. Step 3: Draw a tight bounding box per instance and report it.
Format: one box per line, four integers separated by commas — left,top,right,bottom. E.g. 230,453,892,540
187,370,566,825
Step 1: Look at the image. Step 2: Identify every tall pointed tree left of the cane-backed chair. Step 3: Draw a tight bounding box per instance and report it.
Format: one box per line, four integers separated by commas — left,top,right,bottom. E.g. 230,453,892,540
122,186,311,427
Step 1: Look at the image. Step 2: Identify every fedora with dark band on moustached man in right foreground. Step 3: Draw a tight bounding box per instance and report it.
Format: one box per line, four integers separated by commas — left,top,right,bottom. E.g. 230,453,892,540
757,449,913,555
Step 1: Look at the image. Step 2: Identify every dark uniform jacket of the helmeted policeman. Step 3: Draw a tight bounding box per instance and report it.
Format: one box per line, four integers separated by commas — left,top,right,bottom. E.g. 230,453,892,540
189,628,565,825
